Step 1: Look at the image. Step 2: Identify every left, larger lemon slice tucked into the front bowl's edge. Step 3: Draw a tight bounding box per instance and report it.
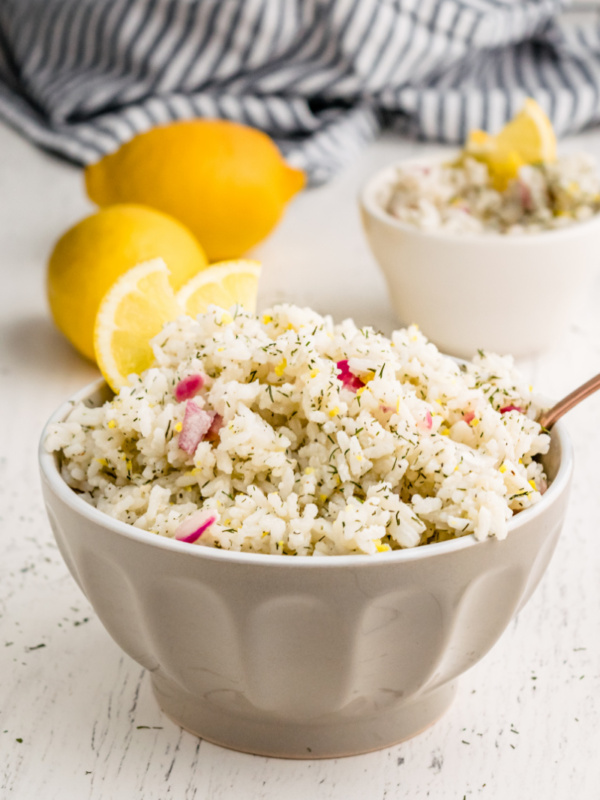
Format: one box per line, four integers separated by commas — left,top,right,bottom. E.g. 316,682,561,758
94,258,183,392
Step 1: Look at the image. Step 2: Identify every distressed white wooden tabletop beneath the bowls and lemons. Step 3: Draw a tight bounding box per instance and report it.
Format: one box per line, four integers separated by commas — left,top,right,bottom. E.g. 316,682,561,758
0,120,600,800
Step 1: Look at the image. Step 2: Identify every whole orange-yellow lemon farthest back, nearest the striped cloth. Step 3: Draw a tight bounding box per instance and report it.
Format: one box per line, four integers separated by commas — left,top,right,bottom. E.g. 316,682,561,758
85,119,305,261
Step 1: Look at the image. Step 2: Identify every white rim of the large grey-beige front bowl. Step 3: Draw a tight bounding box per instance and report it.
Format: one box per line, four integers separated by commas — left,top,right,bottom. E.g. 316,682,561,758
38,378,573,569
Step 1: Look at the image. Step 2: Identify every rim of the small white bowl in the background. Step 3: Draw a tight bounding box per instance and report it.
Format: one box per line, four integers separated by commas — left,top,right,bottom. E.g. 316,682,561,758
358,150,600,248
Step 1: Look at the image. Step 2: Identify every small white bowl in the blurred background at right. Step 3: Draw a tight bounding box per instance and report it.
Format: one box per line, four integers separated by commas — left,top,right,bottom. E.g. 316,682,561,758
359,154,600,358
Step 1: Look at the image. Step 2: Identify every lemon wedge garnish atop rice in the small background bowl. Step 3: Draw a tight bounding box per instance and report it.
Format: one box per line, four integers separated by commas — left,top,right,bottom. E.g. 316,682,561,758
465,98,556,191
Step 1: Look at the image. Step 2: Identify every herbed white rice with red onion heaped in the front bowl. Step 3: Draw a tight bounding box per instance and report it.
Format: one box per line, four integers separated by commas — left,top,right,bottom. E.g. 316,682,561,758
45,305,550,556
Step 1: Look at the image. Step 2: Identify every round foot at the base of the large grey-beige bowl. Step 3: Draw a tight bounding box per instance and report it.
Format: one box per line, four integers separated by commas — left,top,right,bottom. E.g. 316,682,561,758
152,673,456,759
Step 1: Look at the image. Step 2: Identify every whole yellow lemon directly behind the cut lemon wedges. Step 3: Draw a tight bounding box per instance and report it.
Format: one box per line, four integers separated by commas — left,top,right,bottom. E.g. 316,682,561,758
47,205,208,360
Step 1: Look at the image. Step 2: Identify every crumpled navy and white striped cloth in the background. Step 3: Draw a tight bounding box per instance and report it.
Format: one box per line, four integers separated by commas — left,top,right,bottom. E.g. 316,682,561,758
0,0,600,183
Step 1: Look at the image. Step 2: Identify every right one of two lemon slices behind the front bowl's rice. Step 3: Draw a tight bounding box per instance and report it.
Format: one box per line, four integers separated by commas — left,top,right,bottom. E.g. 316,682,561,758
177,259,261,317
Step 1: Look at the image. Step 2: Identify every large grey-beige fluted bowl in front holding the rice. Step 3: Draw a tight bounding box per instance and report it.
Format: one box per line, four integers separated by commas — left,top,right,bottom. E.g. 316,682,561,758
40,381,572,758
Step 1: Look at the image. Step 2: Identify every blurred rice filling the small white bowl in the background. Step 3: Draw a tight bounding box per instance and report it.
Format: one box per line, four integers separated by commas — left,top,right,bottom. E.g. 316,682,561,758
384,154,600,235
